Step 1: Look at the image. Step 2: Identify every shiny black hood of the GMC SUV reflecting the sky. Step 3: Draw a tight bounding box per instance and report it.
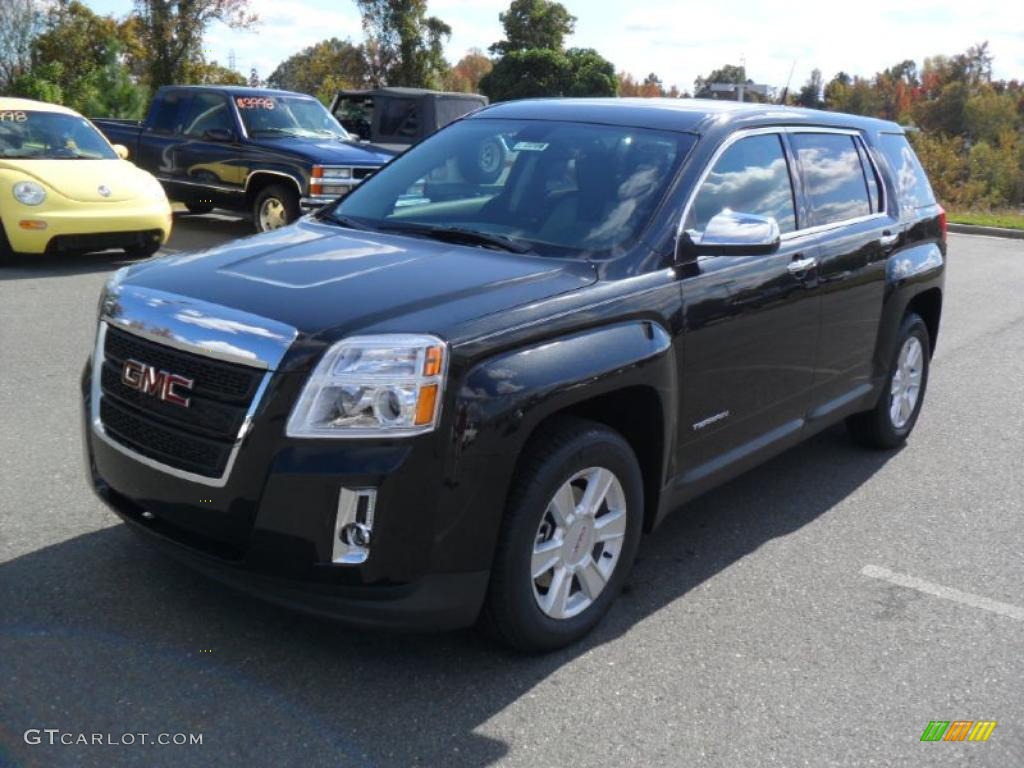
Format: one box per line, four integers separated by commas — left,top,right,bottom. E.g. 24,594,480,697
124,218,596,339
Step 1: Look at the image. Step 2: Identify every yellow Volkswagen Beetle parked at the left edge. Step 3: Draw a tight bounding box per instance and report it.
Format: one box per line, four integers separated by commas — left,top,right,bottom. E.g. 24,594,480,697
0,97,171,260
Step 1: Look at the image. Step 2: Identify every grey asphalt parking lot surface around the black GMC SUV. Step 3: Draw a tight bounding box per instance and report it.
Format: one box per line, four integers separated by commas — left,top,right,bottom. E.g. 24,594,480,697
0,224,1024,768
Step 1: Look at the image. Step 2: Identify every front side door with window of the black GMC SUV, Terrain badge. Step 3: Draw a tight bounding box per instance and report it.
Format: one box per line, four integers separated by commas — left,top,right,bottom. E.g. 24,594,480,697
679,129,819,484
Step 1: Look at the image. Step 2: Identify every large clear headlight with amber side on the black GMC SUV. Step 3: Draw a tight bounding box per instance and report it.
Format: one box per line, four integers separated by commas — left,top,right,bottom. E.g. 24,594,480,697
286,334,447,437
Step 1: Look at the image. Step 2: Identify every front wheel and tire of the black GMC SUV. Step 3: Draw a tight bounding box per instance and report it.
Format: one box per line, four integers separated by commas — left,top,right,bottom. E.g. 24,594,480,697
482,419,643,651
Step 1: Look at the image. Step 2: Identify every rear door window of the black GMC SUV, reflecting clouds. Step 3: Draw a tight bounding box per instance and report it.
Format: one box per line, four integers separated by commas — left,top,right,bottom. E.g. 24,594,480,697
790,133,871,226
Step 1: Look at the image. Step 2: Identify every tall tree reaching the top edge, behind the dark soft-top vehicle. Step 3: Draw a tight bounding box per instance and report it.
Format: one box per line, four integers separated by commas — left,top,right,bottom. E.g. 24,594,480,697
355,0,452,88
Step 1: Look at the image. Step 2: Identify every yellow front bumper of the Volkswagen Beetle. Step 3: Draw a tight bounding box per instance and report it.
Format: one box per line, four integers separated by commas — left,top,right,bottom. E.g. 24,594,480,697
3,201,172,254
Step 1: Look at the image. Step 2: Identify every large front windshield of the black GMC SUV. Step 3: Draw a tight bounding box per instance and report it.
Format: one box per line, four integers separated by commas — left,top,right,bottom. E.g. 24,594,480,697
325,118,694,258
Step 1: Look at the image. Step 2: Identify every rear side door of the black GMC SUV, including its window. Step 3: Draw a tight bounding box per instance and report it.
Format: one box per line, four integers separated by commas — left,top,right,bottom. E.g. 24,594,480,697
786,128,899,420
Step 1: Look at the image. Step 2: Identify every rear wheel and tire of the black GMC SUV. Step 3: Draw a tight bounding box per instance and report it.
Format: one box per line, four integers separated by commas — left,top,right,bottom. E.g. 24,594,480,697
846,312,931,449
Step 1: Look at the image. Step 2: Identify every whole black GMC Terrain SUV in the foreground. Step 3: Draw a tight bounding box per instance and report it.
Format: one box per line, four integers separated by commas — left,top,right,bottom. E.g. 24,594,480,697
82,94,946,649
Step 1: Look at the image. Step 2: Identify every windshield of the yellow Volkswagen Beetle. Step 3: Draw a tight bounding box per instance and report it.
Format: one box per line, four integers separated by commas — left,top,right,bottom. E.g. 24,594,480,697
0,110,118,160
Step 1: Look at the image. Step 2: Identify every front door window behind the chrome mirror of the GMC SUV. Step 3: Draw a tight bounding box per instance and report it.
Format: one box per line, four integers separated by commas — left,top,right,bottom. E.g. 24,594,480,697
685,133,797,232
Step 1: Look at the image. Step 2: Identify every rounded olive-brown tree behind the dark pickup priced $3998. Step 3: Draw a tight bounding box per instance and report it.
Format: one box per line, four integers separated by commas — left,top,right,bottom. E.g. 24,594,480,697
266,38,369,104
